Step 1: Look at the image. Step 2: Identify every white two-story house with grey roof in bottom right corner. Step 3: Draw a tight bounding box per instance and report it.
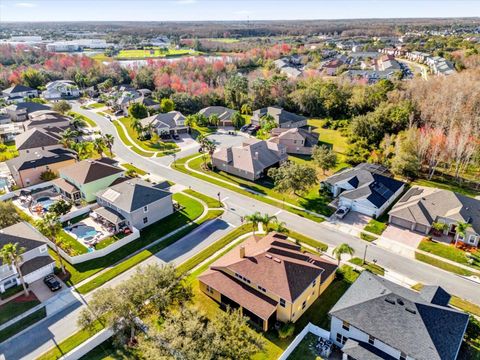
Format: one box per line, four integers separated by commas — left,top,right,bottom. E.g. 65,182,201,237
329,271,469,360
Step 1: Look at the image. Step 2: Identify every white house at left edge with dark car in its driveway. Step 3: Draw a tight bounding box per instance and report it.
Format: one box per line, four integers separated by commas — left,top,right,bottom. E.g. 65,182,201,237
0,222,55,293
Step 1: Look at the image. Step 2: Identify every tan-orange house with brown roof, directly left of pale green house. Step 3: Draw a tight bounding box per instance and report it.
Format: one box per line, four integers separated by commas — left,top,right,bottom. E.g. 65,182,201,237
6,146,77,187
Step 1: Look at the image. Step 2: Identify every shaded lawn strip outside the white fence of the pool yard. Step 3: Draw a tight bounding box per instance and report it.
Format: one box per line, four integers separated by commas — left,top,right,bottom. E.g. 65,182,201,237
50,193,203,285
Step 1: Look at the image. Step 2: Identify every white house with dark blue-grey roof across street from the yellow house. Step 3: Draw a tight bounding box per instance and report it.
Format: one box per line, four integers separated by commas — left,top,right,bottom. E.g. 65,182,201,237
322,164,405,218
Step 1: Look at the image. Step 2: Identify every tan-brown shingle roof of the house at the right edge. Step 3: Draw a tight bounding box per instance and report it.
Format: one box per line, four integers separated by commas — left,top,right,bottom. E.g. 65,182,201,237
389,186,480,234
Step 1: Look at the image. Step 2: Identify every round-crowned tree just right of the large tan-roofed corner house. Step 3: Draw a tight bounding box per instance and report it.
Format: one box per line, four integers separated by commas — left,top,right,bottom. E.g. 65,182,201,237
268,161,317,195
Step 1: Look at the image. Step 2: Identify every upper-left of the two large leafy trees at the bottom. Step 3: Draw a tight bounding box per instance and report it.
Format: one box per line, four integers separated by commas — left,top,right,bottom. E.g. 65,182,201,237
78,264,192,344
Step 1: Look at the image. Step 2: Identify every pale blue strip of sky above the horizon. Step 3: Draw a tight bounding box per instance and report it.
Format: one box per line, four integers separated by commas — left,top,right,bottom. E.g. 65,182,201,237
0,0,480,21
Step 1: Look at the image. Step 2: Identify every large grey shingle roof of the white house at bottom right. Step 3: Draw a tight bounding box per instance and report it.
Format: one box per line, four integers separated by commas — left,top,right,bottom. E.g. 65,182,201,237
330,271,469,360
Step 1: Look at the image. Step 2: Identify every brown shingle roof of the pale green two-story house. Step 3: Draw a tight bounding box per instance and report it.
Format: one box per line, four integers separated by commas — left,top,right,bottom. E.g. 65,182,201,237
60,160,123,184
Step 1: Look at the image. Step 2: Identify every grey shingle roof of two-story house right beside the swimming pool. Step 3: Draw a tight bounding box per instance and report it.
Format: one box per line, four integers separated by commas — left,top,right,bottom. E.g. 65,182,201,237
97,178,171,212
